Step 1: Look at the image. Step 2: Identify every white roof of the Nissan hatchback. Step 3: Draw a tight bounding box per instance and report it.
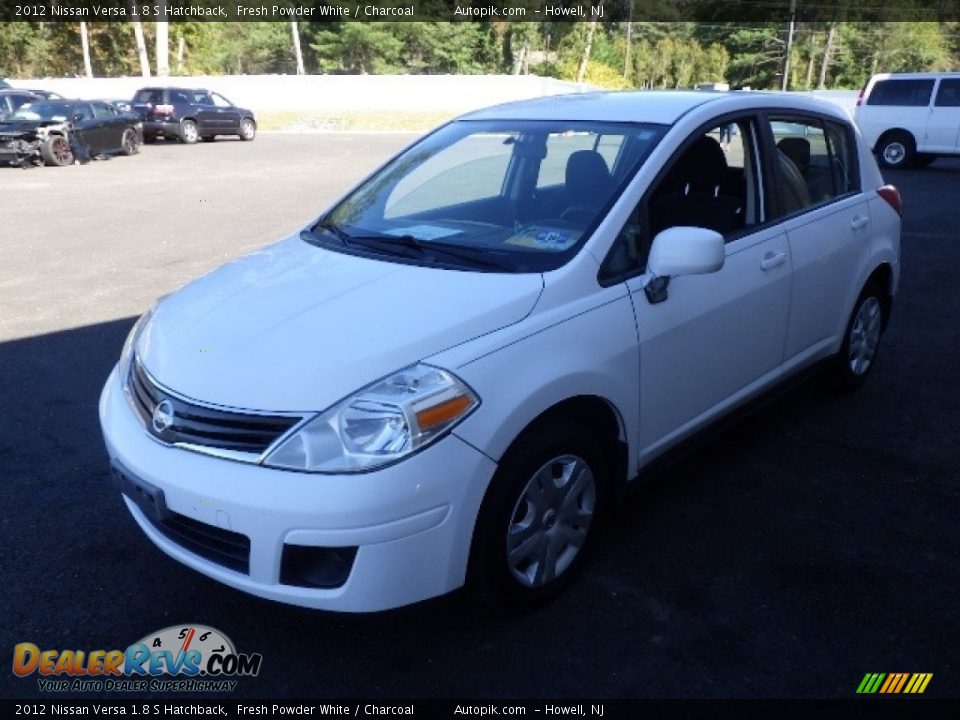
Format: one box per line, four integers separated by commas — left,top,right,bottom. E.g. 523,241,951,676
460,90,843,125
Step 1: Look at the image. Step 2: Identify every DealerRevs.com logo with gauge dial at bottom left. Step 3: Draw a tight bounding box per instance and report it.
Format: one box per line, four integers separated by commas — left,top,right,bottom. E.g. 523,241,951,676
13,625,263,692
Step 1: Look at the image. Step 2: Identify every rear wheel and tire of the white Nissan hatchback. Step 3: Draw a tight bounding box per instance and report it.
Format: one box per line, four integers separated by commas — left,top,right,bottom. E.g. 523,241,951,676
829,282,888,392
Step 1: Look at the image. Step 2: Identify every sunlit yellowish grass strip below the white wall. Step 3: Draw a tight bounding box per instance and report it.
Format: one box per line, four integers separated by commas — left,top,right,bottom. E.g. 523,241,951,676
257,110,456,132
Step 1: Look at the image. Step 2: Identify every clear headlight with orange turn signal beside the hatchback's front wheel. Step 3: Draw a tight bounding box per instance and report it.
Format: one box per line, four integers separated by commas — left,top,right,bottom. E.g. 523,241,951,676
263,365,480,473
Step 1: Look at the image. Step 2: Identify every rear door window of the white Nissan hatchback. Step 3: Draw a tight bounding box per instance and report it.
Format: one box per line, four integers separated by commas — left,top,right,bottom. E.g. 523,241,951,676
770,116,857,217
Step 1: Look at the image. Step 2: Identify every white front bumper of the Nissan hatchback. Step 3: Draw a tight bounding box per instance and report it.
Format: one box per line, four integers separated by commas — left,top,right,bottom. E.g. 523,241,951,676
100,368,496,612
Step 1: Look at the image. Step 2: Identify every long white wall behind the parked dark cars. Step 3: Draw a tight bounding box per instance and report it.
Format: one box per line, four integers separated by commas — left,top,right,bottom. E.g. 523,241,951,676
3,75,595,113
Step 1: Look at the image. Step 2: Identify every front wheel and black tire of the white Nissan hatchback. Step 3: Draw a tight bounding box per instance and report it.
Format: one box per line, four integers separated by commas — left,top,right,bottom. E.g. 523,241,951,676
467,419,608,610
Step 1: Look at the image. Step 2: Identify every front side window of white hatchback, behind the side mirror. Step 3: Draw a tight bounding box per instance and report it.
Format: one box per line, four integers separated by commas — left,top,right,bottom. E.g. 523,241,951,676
600,117,767,282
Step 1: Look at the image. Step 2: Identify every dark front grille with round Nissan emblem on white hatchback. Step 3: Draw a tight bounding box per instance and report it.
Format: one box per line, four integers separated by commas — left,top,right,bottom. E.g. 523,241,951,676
127,360,302,455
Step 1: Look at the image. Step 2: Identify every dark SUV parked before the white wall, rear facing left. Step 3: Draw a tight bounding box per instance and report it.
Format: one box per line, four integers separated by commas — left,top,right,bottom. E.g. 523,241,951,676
131,87,257,144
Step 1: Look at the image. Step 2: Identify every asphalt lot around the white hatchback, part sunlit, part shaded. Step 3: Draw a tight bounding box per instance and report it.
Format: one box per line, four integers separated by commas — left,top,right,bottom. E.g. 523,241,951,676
0,134,960,699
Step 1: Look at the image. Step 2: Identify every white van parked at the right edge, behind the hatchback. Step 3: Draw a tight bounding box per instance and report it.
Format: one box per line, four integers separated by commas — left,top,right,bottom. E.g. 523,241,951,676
854,72,960,168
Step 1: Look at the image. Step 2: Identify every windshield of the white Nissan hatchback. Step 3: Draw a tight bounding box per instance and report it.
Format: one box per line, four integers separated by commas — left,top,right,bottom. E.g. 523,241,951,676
313,120,666,272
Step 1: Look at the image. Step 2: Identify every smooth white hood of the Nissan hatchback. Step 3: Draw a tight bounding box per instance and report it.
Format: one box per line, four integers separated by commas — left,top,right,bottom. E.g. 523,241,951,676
137,237,543,411
